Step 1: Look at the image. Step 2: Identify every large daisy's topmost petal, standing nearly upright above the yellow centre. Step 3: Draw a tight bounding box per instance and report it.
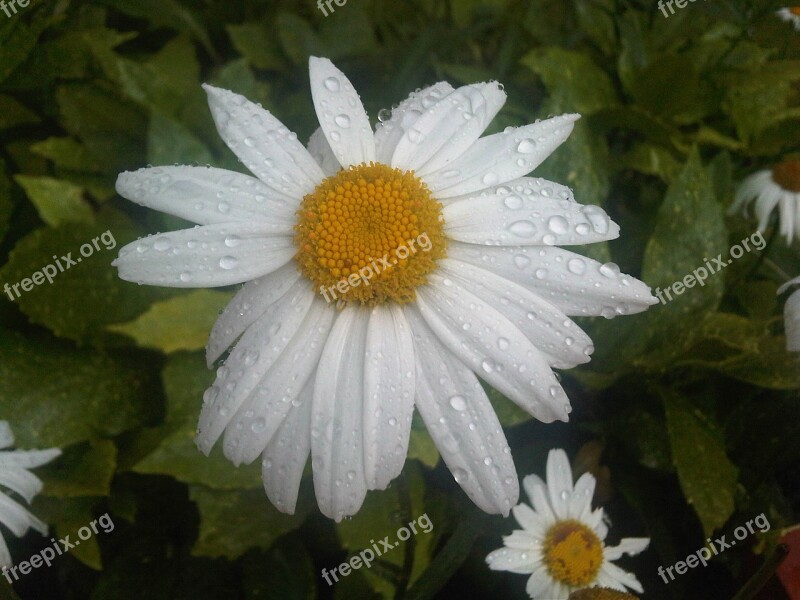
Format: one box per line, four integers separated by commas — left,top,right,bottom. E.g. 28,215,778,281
308,56,375,168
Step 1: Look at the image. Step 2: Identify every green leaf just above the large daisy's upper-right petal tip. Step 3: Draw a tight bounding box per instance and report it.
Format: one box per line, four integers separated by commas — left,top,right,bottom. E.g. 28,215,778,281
522,47,617,116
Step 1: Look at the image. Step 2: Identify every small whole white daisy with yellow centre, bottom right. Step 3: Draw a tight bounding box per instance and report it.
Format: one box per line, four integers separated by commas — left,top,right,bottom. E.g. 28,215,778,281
486,449,650,600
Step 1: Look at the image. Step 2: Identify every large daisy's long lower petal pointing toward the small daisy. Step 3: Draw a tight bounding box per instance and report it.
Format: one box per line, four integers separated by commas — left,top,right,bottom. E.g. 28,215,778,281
406,305,519,515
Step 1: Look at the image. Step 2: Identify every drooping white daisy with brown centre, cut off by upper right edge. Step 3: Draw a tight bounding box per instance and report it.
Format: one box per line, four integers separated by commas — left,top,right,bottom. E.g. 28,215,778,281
728,159,800,244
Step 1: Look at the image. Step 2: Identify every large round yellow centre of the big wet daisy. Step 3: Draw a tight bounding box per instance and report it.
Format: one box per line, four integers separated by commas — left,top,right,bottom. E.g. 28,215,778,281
295,163,446,306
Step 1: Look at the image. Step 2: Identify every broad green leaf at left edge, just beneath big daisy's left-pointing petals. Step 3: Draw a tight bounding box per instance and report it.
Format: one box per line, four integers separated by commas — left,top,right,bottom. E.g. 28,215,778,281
0,210,175,342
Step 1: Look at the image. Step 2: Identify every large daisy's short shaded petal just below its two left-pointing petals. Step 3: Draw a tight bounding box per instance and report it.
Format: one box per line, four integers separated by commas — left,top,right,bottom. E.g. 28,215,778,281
206,262,300,368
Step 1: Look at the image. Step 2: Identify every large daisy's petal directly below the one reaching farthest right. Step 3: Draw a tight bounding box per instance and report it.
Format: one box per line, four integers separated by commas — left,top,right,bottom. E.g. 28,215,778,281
439,258,594,369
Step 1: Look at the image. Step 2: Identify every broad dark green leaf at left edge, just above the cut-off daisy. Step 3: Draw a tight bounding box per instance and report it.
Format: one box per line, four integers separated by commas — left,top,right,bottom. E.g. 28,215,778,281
0,330,154,448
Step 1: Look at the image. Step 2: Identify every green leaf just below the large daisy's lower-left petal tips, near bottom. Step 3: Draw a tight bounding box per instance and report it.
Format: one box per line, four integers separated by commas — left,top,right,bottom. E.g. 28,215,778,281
189,485,307,560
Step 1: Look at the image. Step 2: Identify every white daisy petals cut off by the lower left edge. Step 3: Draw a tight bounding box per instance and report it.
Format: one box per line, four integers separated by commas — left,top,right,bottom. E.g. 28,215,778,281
0,421,61,567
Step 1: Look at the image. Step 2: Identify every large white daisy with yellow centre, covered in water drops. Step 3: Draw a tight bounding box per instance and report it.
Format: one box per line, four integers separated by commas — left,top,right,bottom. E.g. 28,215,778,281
114,57,656,519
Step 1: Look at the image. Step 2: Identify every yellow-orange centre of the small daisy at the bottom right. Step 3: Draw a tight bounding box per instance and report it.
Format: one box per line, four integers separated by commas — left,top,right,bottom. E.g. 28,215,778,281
544,519,603,587
